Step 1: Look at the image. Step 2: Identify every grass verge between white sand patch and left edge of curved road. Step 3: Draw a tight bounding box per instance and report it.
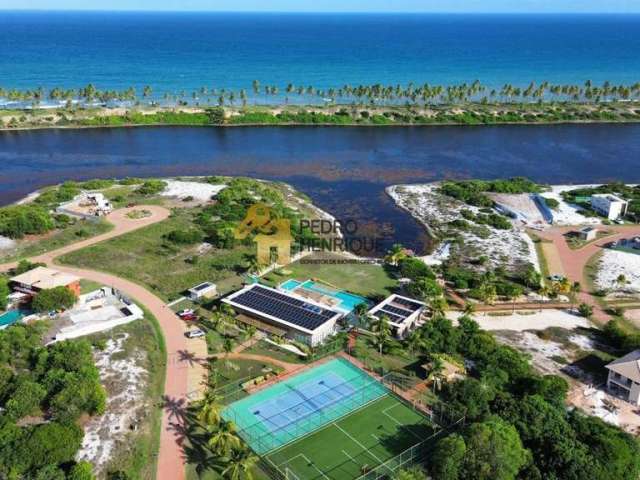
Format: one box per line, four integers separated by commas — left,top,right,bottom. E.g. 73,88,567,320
90,310,166,480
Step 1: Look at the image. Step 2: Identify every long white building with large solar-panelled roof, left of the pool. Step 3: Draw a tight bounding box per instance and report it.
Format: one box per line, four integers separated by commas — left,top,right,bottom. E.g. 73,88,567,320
222,283,344,346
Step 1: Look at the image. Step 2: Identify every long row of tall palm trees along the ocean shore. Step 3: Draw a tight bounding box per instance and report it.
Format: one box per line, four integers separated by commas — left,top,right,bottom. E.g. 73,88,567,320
0,80,640,106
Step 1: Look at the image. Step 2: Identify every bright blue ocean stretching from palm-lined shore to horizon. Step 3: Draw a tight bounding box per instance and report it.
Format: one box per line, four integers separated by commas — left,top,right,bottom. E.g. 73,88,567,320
0,11,640,96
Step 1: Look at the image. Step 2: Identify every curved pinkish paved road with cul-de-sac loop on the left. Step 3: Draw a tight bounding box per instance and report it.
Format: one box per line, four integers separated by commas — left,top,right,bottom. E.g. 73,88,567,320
0,205,206,480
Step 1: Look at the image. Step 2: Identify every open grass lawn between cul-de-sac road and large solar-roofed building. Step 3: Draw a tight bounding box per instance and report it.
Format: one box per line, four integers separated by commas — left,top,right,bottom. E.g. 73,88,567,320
60,209,253,300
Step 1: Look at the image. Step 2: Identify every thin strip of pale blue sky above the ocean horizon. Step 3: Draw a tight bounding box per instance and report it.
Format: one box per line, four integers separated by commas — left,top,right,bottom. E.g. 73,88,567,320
0,0,640,13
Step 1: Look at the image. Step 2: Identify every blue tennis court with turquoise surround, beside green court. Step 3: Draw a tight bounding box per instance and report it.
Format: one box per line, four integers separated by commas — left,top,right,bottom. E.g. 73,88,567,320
222,359,388,454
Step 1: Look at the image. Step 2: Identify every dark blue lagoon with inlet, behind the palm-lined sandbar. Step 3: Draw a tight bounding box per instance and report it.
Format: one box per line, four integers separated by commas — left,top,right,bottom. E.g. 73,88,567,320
0,124,640,255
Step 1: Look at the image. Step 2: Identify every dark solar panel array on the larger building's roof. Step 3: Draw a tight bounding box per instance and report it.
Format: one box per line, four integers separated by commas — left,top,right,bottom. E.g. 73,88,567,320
231,285,336,330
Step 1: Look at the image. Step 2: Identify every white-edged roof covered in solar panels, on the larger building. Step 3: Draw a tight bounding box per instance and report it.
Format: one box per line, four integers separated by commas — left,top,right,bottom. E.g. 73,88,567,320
222,283,342,334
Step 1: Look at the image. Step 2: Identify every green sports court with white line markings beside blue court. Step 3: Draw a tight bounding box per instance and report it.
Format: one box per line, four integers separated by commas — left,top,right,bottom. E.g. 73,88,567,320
267,394,435,480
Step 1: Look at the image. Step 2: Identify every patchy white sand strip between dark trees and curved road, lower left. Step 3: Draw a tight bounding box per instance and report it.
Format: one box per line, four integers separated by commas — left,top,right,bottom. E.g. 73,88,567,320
76,334,147,472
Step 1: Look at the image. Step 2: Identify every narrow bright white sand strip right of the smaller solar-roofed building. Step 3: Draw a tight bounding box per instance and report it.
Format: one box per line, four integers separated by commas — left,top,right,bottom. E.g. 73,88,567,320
447,307,591,332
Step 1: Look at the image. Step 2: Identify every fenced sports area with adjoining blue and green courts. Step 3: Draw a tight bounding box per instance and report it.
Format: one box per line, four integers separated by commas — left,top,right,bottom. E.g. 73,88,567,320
222,358,434,480
